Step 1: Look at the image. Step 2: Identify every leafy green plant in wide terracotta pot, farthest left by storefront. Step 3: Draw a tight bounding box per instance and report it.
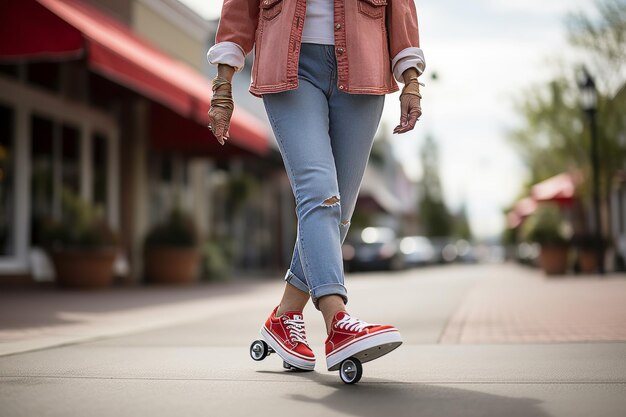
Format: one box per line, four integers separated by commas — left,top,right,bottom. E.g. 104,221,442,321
43,189,118,288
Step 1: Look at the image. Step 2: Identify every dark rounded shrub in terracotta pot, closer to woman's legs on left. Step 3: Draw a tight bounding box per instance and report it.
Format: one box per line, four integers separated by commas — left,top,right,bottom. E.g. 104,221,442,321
144,207,200,284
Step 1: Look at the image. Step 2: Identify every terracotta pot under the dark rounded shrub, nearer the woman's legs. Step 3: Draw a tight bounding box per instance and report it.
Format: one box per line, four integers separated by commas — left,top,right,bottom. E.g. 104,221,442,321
144,247,200,284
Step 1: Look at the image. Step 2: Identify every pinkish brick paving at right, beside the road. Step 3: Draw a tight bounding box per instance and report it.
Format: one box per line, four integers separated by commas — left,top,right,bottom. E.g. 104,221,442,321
440,265,626,343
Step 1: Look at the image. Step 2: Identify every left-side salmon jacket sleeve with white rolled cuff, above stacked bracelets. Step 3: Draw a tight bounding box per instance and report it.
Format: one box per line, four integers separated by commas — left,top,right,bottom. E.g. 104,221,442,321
207,0,260,71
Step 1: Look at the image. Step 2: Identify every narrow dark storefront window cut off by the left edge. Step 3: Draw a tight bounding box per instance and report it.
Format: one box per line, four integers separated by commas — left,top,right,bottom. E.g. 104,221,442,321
0,105,16,256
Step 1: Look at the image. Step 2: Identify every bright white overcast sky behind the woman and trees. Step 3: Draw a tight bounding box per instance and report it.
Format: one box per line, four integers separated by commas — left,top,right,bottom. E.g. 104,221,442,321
181,0,593,238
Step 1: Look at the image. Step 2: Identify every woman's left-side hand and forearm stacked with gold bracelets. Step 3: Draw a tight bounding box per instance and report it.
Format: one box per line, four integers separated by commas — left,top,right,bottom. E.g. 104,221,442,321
208,64,235,145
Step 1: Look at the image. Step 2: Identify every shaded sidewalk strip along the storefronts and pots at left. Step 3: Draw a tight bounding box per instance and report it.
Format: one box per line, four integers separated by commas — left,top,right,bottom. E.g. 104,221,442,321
0,279,279,356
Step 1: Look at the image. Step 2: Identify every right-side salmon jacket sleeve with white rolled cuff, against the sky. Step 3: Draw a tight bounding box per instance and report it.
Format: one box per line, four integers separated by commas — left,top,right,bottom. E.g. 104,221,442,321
386,0,426,83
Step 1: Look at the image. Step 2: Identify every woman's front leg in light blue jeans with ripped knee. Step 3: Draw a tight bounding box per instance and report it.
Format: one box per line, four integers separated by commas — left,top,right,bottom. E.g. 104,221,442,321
263,43,347,308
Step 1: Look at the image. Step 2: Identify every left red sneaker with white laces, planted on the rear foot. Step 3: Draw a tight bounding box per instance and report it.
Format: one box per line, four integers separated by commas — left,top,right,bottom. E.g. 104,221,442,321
261,306,315,370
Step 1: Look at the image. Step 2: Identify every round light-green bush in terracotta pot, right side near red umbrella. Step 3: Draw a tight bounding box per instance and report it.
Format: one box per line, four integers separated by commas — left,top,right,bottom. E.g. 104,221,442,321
522,204,569,275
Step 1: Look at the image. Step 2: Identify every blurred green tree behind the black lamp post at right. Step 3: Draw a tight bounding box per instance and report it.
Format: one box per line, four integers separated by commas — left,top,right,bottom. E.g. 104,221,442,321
510,0,626,234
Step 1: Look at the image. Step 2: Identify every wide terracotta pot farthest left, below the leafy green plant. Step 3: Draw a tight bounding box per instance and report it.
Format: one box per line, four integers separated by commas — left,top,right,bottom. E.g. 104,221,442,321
49,248,117,289
